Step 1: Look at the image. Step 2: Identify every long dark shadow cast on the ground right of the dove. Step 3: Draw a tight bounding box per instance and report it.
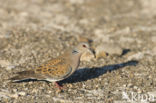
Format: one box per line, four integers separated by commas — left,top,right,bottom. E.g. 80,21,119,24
59,60,139,84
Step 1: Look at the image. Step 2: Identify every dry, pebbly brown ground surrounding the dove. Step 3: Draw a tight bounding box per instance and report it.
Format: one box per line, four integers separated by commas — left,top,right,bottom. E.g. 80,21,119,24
0,0,156,103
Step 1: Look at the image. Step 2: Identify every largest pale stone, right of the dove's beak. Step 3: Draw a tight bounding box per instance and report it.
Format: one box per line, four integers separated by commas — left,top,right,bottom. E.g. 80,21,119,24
95,43,123,57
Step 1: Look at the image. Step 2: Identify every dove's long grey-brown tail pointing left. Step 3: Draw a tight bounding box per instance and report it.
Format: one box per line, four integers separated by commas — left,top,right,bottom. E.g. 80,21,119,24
9,70,42,82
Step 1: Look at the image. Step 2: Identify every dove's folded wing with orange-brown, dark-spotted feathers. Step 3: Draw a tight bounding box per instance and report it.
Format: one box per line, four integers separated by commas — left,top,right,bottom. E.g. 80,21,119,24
35,58,72,81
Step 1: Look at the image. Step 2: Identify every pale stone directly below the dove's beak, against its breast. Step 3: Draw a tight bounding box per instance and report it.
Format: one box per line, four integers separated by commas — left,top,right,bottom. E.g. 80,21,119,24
80,50,95,61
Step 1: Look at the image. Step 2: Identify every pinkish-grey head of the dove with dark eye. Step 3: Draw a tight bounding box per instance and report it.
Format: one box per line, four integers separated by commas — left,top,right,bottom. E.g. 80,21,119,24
72,43,90,53
